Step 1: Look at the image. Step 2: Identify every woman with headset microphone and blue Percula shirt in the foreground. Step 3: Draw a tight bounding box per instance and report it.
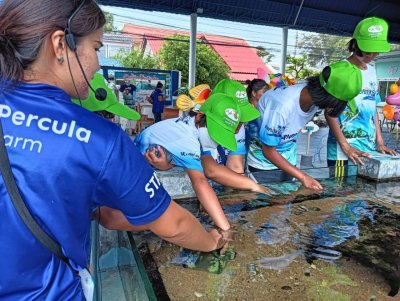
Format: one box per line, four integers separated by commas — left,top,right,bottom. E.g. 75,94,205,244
0,0,224,301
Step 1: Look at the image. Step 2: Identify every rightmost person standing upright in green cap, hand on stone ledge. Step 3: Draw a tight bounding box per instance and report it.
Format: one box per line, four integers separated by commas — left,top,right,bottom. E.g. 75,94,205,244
326,17,397,176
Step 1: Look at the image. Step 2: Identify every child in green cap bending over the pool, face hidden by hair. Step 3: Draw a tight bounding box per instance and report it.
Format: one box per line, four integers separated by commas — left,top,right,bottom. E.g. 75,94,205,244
247,61,361,189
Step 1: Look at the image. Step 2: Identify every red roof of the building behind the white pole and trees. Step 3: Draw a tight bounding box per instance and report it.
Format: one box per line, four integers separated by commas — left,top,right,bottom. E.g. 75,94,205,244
123,24,275,82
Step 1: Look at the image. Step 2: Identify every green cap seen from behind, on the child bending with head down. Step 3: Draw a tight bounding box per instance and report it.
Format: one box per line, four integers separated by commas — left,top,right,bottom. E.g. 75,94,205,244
319,61,362,112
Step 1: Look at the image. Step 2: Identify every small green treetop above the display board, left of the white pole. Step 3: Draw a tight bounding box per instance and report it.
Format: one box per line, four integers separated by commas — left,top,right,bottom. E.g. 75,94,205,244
114,48,160,69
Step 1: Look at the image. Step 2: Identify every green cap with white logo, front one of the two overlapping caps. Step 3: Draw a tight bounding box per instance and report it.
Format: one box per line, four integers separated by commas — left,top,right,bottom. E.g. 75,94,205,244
200,93,240,151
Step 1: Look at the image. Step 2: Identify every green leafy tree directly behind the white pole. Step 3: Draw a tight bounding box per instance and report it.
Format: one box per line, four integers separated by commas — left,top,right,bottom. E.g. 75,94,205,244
158,35,229,87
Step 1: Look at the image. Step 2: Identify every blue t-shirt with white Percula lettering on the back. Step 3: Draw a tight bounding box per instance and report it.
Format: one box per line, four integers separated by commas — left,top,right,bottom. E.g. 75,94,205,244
0,84,171,301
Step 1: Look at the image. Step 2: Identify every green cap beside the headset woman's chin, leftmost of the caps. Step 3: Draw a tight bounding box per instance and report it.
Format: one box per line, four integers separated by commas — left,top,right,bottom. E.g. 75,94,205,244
72,73,140,120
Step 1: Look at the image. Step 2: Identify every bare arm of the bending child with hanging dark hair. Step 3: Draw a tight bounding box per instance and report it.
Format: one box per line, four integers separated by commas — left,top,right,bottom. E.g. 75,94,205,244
262,144,322,190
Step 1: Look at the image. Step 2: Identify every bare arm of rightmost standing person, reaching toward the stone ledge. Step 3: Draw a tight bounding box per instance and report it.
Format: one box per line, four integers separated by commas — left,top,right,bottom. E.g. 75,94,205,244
325,110,371,164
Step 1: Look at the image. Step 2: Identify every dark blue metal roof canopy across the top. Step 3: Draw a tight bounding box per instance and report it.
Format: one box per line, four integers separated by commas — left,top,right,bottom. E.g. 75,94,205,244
99,0,400,43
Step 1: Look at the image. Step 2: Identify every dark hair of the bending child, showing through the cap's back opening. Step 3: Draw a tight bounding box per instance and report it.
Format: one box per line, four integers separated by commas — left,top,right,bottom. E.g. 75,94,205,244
307,66,347,117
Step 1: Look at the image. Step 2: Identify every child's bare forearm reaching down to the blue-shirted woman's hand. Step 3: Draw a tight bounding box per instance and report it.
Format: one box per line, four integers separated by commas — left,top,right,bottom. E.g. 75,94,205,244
186,169,230,230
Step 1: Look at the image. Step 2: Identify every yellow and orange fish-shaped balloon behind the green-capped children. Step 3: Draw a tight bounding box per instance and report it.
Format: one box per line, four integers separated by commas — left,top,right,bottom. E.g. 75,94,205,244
176,84,211,111
